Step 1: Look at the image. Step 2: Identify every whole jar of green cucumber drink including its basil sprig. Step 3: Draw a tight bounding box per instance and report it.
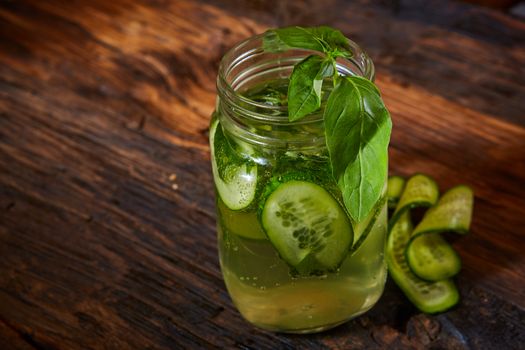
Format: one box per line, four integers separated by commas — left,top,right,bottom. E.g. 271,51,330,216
210,28,390,333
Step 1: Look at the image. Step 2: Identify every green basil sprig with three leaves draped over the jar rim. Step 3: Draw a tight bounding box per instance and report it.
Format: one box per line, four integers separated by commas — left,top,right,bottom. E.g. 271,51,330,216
263,27,392,222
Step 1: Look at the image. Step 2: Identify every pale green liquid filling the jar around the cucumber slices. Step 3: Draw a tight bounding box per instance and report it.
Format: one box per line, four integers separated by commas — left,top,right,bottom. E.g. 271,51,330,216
217,79,387,333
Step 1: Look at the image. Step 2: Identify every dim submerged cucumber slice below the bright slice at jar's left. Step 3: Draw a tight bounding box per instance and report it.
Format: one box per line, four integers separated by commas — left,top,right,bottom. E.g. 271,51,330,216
217,197,267,239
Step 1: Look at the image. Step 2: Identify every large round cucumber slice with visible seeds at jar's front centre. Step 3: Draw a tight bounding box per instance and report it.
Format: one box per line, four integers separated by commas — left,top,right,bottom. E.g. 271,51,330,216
261,180,353,275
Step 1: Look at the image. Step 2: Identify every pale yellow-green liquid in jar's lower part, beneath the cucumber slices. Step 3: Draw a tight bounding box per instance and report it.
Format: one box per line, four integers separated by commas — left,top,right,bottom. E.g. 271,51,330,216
218,205,387,333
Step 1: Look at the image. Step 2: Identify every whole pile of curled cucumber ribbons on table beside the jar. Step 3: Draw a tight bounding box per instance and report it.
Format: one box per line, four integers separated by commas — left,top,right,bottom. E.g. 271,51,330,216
386,174,473,313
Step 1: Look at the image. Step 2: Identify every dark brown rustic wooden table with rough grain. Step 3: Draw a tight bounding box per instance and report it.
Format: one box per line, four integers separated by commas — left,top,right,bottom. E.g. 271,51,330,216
0,0,525,349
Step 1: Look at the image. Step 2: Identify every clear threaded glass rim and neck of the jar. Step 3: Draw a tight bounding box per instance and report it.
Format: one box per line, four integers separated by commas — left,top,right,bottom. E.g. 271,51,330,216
216,33,375,151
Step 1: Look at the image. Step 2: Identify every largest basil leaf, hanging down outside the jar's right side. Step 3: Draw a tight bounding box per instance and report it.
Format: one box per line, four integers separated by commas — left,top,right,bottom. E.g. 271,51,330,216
324,77,392,222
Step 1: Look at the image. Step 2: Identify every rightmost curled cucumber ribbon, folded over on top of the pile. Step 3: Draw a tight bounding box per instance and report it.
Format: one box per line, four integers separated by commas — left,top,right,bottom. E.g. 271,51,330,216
406,186,474,281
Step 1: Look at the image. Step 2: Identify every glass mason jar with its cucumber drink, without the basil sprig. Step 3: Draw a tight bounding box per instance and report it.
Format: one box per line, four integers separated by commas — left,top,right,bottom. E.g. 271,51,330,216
210,35,387,333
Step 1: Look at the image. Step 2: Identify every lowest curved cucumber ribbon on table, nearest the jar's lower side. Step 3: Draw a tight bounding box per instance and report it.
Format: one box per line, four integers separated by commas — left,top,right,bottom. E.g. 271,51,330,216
386,211,459,314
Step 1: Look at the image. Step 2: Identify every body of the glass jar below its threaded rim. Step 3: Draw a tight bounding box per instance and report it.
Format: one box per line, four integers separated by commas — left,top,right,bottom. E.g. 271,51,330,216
210,34,387,333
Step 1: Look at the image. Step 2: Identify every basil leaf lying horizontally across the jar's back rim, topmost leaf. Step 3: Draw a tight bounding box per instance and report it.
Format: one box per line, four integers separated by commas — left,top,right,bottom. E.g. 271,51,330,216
263,26,351,57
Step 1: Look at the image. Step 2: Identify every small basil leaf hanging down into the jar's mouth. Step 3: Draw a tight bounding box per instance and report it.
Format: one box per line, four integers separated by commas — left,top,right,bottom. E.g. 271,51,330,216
288,55,333,121
